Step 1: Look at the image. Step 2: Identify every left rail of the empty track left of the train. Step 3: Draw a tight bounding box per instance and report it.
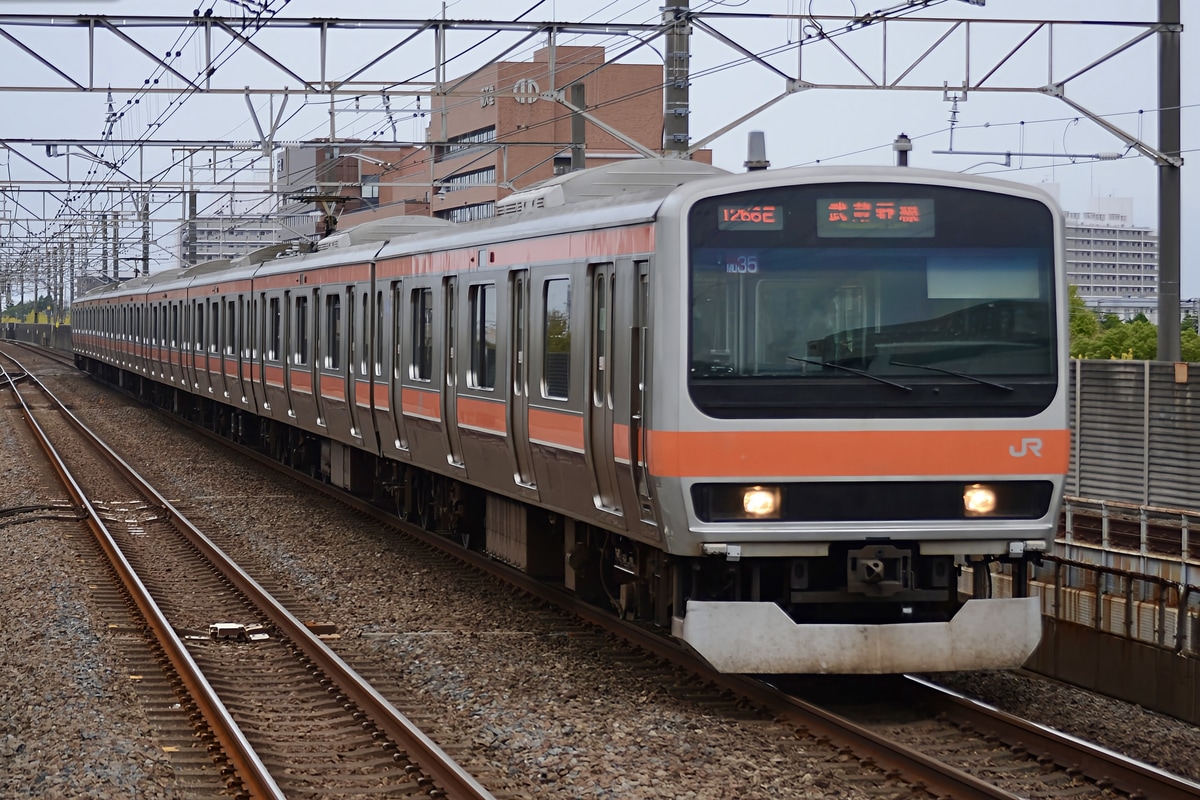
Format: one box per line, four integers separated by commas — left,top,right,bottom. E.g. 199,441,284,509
0,355,284,800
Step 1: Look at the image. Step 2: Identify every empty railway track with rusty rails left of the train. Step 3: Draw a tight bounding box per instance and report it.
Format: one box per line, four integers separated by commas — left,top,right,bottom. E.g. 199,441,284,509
0,357,492,799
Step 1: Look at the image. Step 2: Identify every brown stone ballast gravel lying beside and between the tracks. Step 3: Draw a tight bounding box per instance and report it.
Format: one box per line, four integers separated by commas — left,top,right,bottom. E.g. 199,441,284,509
7,357,1200,800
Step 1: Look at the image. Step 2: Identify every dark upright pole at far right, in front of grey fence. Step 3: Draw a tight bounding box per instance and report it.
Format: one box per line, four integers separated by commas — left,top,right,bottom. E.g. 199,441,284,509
1158,0,1183,361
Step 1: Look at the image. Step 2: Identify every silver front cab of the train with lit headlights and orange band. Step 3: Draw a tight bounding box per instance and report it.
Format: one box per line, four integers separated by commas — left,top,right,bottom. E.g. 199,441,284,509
649,169,1068,673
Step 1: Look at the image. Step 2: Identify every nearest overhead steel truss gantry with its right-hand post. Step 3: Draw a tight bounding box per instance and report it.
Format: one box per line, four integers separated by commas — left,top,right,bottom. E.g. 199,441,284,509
0,6,1183,360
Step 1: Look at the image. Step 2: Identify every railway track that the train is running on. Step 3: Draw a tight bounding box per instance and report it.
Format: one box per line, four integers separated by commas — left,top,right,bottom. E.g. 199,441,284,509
157,381,1200,800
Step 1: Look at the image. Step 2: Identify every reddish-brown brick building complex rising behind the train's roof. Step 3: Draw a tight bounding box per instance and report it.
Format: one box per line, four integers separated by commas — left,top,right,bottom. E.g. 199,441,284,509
276,47,712,232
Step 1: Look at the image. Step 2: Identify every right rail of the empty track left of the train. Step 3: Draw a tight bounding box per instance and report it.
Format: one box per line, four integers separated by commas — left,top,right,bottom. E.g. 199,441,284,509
2,356,494,800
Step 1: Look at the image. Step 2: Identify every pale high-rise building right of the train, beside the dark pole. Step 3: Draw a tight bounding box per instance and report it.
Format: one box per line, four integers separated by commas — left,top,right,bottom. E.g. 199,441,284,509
1066,197,1158,307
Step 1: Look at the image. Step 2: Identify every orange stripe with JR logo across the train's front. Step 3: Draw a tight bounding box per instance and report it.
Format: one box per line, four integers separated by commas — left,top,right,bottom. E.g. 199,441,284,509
648,431,1070,477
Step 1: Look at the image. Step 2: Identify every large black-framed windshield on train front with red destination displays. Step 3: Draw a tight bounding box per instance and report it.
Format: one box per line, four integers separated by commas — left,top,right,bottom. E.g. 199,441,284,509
689,184,1058,416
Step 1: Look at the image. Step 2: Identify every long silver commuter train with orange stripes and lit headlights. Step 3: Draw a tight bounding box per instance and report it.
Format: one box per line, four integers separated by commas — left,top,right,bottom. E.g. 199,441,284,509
72,158,1069,674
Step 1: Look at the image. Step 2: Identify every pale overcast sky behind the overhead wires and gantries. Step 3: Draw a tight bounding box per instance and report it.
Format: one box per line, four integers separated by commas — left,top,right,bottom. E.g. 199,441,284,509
0,0,1200,297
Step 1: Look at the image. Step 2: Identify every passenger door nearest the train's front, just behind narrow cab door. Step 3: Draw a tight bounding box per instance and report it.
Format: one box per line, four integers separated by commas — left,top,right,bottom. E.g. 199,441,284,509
586,264,620,513
